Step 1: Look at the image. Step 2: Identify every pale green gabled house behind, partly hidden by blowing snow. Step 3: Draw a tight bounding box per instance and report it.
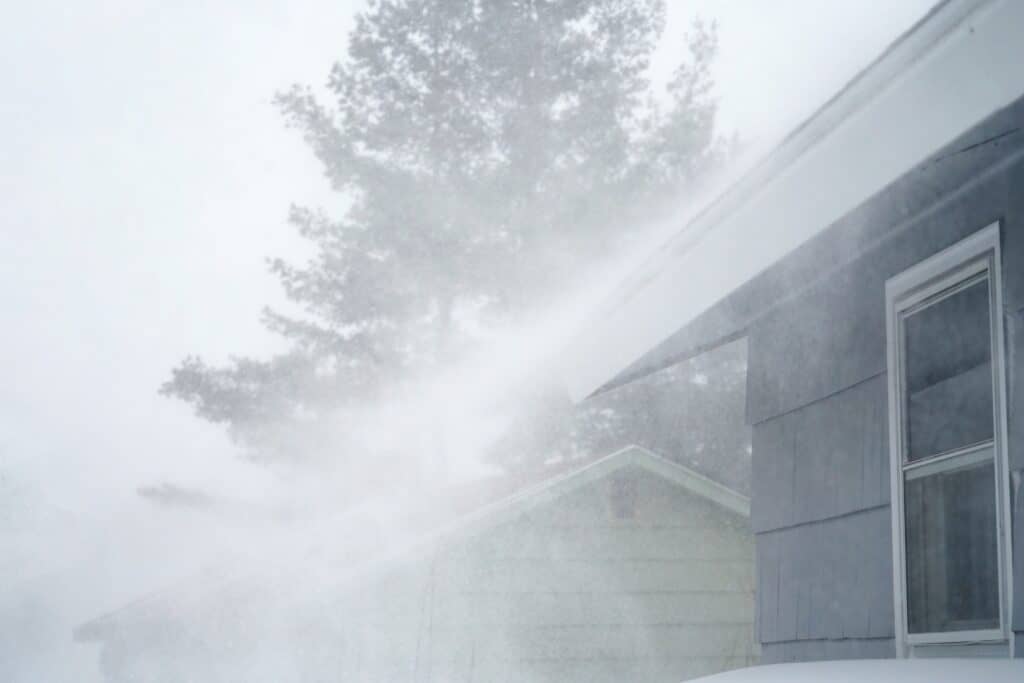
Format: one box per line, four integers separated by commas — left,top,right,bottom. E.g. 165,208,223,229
76,446,758,682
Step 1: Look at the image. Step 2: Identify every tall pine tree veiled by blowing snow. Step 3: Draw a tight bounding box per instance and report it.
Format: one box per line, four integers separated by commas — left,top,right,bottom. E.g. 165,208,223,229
161,0,721,481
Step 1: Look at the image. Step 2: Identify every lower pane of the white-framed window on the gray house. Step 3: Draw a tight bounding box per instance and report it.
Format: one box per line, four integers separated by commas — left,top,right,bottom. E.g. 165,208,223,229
904,456,999,633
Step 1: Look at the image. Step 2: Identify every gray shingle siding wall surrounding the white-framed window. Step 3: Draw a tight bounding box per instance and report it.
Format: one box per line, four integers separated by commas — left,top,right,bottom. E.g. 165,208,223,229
748,103,1024,663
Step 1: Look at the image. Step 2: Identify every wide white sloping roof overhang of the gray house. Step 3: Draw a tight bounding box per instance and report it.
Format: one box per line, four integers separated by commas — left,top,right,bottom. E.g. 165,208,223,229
561,0,1024,400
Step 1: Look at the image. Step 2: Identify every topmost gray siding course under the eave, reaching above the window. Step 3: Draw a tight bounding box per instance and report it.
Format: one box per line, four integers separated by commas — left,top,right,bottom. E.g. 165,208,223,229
748,171,1009,424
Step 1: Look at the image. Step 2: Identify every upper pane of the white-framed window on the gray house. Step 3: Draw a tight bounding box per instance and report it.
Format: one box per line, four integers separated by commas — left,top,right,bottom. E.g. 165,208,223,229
903,279,992,462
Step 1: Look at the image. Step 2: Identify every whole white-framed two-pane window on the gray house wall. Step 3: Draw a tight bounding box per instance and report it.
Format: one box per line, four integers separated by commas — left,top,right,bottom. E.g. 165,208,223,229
886,225,1011,654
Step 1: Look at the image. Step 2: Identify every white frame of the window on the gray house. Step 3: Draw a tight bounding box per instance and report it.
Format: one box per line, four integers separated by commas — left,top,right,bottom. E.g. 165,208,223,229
886,222,1014,656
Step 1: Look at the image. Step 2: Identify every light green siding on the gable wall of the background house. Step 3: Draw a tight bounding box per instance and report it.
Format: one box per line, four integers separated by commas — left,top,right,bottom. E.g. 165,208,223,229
323,470,758,683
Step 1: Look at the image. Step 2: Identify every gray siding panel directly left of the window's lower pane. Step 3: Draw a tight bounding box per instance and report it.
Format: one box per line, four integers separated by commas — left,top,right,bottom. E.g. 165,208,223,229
757,507,893,643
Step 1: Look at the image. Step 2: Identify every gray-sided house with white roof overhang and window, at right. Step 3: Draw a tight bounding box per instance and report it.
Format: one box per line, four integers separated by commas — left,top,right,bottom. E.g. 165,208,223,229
565,0,1024,661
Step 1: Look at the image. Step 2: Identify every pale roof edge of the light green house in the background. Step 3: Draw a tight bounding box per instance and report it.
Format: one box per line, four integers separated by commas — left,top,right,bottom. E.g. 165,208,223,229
75,445,751,641
